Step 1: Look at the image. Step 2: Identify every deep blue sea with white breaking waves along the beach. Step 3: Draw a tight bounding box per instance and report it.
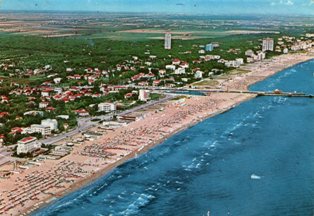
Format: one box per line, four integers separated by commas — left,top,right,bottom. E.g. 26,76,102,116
33,61,314,216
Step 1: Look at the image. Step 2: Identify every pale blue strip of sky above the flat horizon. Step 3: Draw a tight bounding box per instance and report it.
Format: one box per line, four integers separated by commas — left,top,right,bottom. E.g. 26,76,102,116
0,0,314,16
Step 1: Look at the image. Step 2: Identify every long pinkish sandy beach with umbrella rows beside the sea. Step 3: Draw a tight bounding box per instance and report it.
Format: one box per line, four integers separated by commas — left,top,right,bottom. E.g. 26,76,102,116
0,53,314,215
